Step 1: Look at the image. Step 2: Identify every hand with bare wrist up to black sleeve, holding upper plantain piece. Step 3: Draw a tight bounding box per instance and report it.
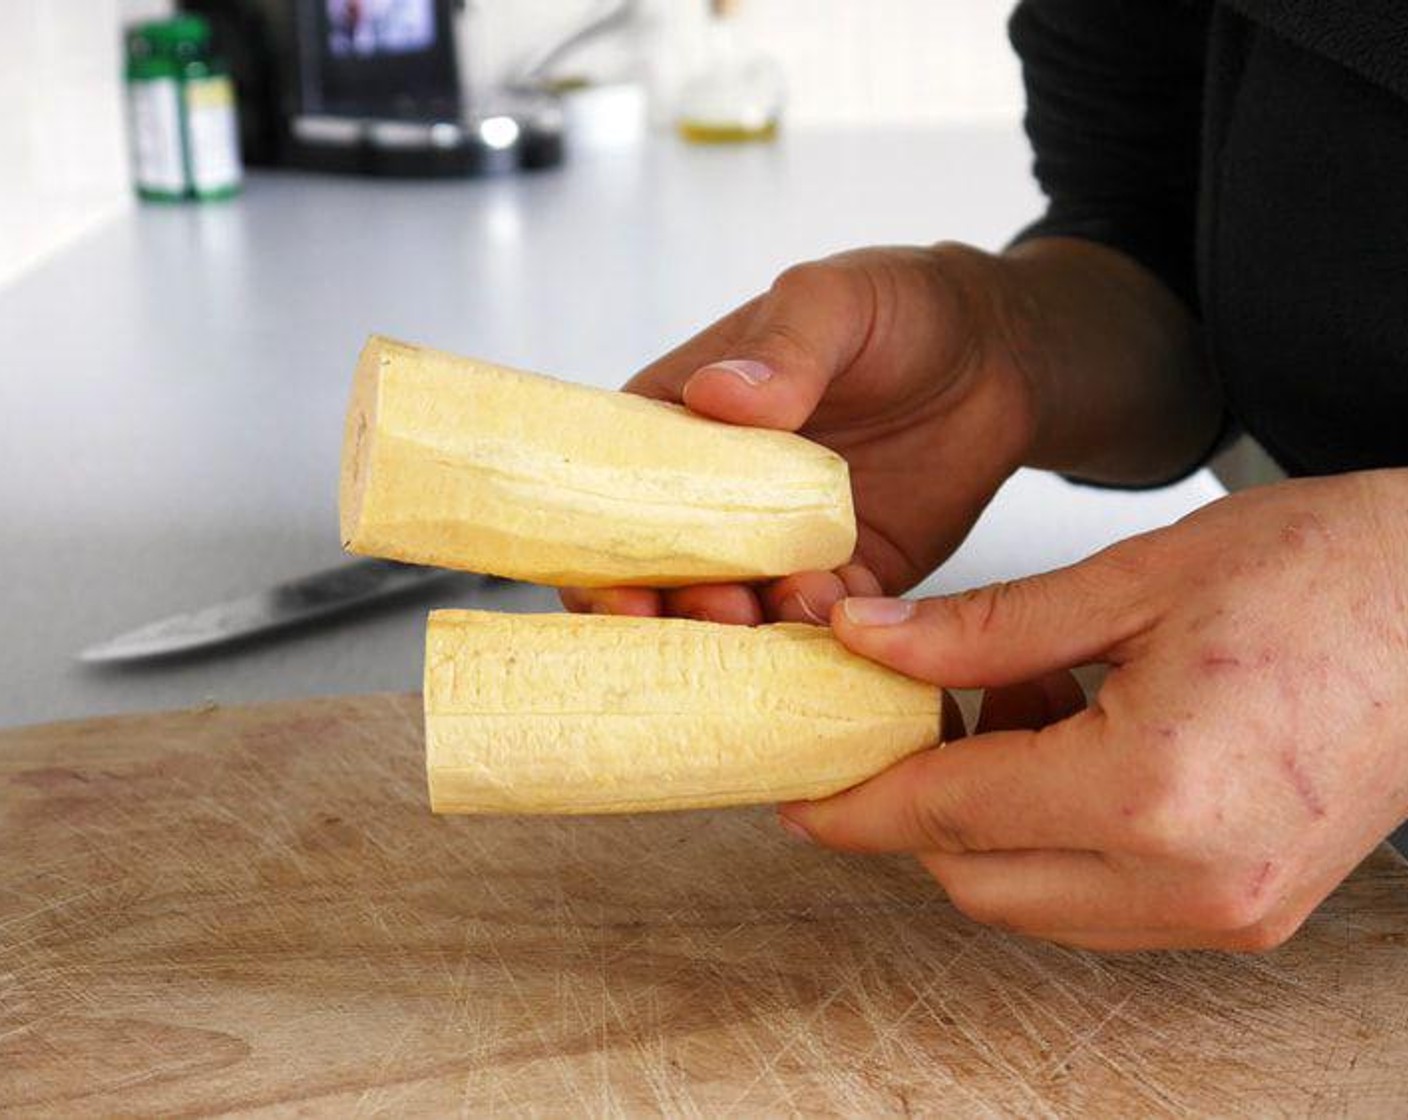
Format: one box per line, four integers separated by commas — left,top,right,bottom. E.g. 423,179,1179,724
562,238,1222,623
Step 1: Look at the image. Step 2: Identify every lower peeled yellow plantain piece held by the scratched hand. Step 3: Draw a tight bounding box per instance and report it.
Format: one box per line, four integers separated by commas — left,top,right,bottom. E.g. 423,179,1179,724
425,610,942,813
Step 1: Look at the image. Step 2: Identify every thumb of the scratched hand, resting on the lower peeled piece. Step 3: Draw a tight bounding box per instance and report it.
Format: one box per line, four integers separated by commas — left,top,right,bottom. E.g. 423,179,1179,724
831,542,1157,689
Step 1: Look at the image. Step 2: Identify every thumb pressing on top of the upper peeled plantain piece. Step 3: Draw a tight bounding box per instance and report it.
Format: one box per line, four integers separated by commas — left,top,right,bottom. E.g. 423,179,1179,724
683,261,876,431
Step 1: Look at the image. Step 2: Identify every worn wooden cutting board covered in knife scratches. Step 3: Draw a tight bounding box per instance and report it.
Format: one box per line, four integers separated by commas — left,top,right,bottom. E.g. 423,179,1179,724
0,696,1408,1117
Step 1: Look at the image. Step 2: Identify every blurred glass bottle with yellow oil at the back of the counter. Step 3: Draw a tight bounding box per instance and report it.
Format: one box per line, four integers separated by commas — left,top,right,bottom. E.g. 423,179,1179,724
676,0,786,144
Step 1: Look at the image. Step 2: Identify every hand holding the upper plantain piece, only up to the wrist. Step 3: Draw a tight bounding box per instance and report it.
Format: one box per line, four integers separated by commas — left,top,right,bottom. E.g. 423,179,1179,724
563,245,1031,623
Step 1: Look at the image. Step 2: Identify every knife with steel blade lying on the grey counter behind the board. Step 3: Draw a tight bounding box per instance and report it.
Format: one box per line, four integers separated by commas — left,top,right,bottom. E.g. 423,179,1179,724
77,559,484,664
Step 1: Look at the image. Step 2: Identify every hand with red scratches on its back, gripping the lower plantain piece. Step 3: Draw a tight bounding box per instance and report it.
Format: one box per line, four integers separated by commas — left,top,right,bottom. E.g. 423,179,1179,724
781,471,1408,950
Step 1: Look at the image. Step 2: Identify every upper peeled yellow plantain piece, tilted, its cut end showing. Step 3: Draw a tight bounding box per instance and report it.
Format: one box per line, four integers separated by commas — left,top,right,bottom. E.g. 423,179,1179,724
339,337,856,586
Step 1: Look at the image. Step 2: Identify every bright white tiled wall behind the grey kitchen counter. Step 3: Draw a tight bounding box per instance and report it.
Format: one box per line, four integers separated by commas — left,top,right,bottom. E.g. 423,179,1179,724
0,0,1021,285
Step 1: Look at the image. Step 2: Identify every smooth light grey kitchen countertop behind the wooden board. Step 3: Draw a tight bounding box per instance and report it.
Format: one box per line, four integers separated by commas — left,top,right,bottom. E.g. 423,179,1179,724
0,128,1221,724
